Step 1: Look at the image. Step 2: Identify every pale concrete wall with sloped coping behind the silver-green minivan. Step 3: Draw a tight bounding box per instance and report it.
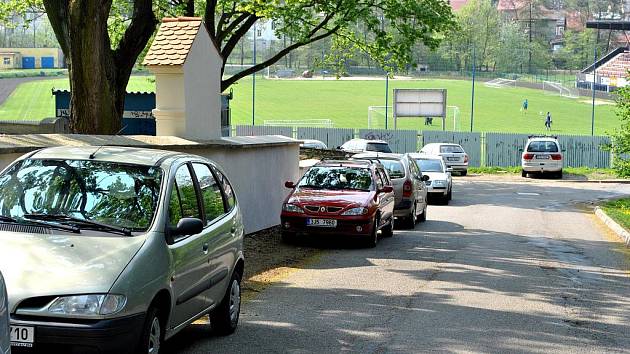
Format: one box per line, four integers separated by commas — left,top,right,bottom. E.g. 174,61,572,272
0,134,299,233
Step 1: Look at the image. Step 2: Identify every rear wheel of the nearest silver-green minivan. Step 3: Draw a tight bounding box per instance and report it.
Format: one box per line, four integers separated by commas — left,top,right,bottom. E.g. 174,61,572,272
210,272,241,336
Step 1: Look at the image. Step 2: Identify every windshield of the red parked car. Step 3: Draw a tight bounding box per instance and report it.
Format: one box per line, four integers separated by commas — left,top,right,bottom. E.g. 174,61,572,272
298,166,372,191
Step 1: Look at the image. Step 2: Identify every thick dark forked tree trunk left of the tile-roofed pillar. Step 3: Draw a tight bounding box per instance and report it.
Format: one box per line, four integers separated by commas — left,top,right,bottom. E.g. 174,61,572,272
43,0,157,134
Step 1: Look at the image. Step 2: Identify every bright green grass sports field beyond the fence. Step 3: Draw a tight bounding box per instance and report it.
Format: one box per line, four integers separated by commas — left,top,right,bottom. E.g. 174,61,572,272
0,76,619,134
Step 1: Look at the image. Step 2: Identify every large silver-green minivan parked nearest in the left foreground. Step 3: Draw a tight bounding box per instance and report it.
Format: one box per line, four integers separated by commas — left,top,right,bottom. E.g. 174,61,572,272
0,147,244,353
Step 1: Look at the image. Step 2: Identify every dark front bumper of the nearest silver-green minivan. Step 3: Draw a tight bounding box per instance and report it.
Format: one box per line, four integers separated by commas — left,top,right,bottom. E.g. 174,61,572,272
11,314,146,354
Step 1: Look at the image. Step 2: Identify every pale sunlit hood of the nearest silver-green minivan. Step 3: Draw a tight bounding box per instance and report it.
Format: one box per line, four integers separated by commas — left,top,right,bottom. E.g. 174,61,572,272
0,232,146,313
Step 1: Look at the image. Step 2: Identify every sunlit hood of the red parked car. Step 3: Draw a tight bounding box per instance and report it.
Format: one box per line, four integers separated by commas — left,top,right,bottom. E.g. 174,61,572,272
288,188,375,207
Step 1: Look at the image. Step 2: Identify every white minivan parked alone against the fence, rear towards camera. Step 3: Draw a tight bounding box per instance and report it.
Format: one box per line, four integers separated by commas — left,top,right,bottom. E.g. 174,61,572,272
521,135,564,178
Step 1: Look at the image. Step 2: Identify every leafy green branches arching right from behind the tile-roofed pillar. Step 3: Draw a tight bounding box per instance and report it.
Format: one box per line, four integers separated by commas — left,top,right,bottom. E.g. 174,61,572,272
204,0,455,90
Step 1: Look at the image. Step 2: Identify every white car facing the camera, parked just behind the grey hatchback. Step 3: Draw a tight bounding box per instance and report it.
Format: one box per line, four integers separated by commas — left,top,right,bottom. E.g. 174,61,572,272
407,154,453,204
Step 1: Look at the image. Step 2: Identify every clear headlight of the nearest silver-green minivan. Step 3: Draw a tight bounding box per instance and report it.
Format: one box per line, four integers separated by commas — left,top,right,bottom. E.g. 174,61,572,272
48,294,127,316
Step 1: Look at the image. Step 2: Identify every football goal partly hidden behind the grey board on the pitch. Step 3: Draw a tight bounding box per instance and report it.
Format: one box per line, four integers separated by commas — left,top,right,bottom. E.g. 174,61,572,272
368,106,462,131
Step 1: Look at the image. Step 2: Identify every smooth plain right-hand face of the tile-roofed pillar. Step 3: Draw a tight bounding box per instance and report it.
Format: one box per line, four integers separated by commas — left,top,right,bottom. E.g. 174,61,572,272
183,25,222,139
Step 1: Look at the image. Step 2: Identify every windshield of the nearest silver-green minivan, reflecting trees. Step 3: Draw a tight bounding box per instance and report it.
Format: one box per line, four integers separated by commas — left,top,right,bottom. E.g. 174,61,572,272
0,159,162,231
